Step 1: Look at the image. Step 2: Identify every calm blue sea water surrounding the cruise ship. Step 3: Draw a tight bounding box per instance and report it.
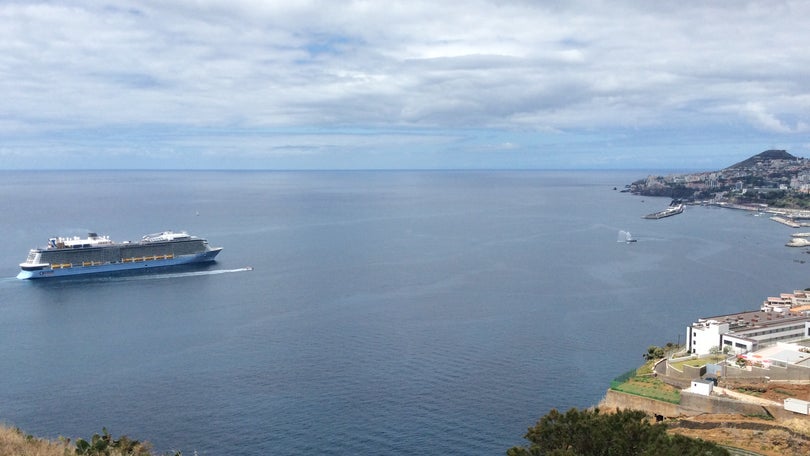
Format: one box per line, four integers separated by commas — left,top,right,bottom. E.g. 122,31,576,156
0,171,810,455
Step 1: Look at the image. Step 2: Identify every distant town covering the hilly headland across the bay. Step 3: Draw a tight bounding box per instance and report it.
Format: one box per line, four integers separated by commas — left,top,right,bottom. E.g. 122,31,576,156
624,150,810,210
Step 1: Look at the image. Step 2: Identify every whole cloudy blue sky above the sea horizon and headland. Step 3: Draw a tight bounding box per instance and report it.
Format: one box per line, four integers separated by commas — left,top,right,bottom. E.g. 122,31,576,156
0,0,810,170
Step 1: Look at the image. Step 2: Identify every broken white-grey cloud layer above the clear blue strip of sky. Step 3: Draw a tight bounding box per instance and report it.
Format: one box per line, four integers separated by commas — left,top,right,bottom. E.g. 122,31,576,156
0,0,810,167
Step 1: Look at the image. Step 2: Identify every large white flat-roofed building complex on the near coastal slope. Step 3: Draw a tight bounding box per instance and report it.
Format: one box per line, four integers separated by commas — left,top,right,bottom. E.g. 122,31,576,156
686,298,810,355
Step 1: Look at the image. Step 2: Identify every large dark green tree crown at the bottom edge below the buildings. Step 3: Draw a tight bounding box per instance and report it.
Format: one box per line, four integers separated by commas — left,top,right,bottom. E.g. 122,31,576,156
506,409,729,456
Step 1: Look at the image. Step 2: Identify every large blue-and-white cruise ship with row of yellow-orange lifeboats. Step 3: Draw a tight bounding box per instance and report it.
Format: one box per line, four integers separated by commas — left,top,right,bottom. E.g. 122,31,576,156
17,231,222,279
